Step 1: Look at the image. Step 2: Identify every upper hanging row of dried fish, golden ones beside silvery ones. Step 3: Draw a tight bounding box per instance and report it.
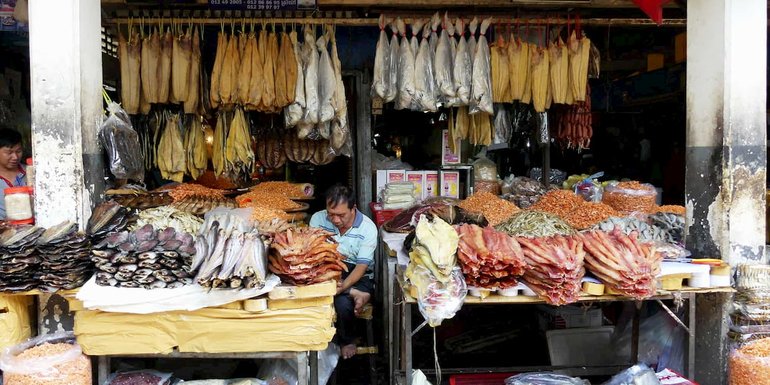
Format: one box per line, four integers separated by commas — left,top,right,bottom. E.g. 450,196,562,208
209,25,352,156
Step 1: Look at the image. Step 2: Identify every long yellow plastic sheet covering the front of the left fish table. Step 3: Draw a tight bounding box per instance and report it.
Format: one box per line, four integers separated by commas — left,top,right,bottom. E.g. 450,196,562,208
75,305,335,355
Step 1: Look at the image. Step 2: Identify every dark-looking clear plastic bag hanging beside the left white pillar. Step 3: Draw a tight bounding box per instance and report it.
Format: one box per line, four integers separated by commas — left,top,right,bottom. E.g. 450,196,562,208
99,102,144,182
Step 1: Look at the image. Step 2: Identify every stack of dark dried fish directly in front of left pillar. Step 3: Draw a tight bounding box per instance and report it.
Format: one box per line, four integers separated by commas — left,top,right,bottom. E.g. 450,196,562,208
36,222,93,291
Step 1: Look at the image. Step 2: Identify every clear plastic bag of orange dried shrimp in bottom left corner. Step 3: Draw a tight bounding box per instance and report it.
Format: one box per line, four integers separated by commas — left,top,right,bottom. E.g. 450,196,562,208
0,332,91,385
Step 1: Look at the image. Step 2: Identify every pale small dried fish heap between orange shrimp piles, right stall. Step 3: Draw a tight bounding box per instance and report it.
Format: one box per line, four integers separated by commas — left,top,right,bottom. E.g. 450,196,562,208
495,210,576,238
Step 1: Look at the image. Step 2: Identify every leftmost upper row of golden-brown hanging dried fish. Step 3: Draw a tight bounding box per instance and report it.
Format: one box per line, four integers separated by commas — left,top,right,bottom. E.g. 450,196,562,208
118,19,202,114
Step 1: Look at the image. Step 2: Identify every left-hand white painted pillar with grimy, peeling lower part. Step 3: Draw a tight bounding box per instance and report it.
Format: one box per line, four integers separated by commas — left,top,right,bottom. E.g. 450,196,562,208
29,0,103,227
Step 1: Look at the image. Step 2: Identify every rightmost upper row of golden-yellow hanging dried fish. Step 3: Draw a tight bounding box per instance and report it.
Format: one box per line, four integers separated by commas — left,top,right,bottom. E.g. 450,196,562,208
491,30,591,112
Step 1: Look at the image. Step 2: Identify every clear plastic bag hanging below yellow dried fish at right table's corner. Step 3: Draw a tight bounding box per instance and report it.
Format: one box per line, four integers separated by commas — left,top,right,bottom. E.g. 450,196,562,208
411,265,468,327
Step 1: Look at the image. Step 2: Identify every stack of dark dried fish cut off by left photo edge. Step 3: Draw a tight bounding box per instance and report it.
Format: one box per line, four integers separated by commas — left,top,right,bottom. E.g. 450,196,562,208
0,226,45,292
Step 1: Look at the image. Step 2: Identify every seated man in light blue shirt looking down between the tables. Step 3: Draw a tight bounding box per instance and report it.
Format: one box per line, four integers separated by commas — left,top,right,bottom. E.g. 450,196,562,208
310,184,377,359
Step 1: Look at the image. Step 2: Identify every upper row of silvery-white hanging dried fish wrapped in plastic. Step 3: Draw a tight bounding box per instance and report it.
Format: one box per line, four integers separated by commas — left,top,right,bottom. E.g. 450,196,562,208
372,13,494,115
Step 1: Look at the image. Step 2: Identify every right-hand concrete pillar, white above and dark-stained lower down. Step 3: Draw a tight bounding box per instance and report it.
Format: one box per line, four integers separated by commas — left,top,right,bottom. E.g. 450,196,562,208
685,0,767,385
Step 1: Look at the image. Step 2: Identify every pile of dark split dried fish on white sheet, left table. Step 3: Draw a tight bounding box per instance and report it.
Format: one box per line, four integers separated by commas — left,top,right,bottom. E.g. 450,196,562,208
91,224,195,289
